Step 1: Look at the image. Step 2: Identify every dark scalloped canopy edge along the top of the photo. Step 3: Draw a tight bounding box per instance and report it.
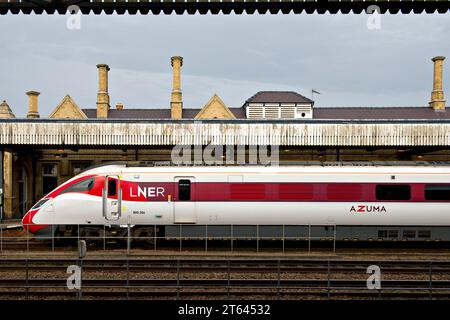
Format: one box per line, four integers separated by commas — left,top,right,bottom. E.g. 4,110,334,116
0,0,450,14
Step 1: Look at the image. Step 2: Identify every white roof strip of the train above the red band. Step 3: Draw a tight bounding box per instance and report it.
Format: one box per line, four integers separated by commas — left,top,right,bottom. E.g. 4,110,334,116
82,161,450,175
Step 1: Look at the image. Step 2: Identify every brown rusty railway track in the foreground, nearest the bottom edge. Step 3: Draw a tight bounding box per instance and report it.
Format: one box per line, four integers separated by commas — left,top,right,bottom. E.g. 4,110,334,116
0,258,450,299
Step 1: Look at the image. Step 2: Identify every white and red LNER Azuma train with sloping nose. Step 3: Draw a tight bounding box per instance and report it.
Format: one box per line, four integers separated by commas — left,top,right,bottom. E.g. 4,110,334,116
22,163,450,241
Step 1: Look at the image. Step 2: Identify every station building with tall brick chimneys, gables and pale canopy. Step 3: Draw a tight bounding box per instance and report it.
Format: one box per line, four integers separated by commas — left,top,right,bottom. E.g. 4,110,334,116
0,56,450,219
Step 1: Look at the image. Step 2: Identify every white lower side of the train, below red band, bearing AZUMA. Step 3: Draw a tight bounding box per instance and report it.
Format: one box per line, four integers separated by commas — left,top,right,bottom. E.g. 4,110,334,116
29,200,450,226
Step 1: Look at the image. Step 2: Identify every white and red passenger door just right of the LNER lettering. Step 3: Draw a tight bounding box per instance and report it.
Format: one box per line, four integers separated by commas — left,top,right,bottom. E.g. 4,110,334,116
173,177,197,223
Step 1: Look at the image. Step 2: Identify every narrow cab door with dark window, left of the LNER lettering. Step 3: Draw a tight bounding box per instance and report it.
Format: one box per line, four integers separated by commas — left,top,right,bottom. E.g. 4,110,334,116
102,175,122,221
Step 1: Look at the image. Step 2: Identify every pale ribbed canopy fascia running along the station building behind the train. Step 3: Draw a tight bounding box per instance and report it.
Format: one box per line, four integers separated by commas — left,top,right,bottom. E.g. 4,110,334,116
0,119,450,147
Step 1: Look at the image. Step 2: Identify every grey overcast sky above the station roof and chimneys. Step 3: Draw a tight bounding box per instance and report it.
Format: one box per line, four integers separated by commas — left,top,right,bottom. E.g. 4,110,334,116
0,14,450,117
